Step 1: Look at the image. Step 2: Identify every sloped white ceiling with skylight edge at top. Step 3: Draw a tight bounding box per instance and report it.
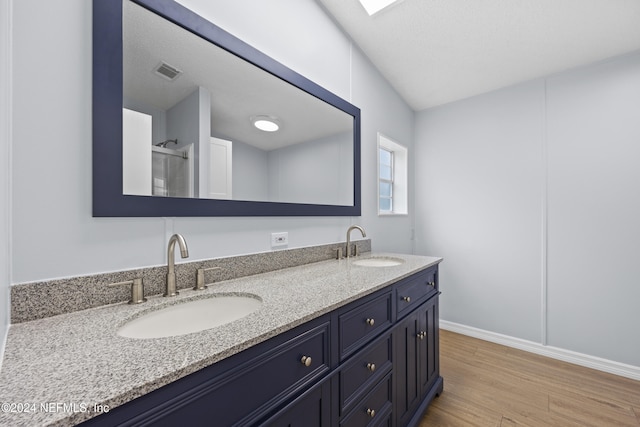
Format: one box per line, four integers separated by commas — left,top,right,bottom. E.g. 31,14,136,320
317,0,640,111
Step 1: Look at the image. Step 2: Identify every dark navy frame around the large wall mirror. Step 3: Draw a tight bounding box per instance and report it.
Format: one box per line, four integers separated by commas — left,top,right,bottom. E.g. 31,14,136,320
93,0,361,217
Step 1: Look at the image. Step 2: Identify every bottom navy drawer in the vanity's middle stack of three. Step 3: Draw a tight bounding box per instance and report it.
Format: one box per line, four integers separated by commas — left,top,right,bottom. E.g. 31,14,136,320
340,373,393,427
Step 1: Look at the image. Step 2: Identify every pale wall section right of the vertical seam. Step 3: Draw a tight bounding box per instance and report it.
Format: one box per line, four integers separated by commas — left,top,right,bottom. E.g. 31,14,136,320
547,54,640,366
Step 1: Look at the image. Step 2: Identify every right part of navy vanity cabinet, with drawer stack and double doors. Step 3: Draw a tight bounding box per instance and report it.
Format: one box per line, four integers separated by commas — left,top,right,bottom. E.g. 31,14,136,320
332,265,442,427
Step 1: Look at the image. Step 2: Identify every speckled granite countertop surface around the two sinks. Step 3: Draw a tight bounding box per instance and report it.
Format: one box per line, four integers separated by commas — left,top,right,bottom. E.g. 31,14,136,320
0,253,442,427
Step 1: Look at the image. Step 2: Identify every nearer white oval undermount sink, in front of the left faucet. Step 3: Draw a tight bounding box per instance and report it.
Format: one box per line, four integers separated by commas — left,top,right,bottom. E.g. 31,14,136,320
118,294,262,339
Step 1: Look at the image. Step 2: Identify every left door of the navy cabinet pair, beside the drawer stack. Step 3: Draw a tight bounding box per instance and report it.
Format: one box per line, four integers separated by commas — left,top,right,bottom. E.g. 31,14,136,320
393,309,421,426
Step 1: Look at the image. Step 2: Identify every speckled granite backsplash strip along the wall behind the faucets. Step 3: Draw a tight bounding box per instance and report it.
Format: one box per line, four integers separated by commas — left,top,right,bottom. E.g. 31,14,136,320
11,239,371,324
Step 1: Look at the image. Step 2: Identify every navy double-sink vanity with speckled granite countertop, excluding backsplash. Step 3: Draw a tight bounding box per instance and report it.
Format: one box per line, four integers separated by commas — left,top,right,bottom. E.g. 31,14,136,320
0,246,442,427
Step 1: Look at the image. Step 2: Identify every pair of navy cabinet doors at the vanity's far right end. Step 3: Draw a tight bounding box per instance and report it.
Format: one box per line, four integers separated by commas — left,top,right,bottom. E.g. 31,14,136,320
394,295,443,426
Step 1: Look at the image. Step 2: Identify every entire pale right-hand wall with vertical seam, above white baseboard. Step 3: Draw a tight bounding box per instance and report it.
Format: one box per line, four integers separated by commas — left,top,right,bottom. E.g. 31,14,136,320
416,54,640,367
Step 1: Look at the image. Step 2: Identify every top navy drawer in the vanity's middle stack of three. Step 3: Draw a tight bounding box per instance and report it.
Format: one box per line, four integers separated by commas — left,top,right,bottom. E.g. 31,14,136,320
338,292,391,360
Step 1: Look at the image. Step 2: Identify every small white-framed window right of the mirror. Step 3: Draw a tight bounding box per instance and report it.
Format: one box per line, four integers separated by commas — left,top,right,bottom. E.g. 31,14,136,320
378,133,408,215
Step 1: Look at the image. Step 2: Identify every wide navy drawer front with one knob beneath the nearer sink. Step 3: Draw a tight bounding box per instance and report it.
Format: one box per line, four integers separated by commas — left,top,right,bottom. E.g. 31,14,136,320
80,316,331,426
